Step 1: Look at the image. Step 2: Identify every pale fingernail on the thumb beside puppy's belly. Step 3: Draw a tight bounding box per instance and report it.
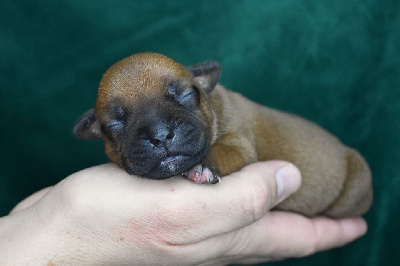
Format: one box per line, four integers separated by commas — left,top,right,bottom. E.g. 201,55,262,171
276,164,301,204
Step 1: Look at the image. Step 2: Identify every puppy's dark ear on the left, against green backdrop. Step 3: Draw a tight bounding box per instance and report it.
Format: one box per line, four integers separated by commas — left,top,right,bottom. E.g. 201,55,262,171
72,109,101,139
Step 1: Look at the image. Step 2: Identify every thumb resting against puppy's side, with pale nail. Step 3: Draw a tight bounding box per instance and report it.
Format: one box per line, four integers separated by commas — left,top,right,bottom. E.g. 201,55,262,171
163,161,301,244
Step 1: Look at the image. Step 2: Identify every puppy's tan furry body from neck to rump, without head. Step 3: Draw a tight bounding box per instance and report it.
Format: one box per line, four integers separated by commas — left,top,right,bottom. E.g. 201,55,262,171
211,86,372,217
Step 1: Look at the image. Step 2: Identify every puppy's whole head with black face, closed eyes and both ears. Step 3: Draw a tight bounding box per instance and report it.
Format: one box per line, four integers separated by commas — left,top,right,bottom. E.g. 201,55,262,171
73,53,220,179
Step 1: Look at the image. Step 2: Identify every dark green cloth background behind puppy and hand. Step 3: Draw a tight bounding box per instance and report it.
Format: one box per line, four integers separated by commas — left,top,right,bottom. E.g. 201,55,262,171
0,0,400,265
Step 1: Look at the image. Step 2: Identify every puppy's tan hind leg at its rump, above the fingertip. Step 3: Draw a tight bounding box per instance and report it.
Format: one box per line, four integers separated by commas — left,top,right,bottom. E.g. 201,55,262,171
323,149,373,217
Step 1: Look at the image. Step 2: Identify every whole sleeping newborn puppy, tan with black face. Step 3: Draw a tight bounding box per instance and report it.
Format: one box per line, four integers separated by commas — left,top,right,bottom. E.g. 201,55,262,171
73,53,372,217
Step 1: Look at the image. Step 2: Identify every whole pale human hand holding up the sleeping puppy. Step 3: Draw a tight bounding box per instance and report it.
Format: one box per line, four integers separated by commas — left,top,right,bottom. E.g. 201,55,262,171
0,161,367,265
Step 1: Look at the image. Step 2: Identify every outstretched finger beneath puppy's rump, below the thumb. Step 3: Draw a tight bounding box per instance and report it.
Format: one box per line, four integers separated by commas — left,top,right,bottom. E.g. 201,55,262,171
214,211,367,263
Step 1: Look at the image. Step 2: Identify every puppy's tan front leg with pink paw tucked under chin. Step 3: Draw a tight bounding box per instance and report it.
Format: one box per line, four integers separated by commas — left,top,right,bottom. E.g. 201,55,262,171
183,134,257,184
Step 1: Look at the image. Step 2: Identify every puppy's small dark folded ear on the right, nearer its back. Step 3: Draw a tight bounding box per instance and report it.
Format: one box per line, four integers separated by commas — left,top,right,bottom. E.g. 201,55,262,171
189,61,221,93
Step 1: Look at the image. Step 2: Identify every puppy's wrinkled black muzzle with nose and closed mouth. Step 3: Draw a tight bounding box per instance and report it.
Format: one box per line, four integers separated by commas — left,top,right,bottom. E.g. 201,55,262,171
122,118,208,179
